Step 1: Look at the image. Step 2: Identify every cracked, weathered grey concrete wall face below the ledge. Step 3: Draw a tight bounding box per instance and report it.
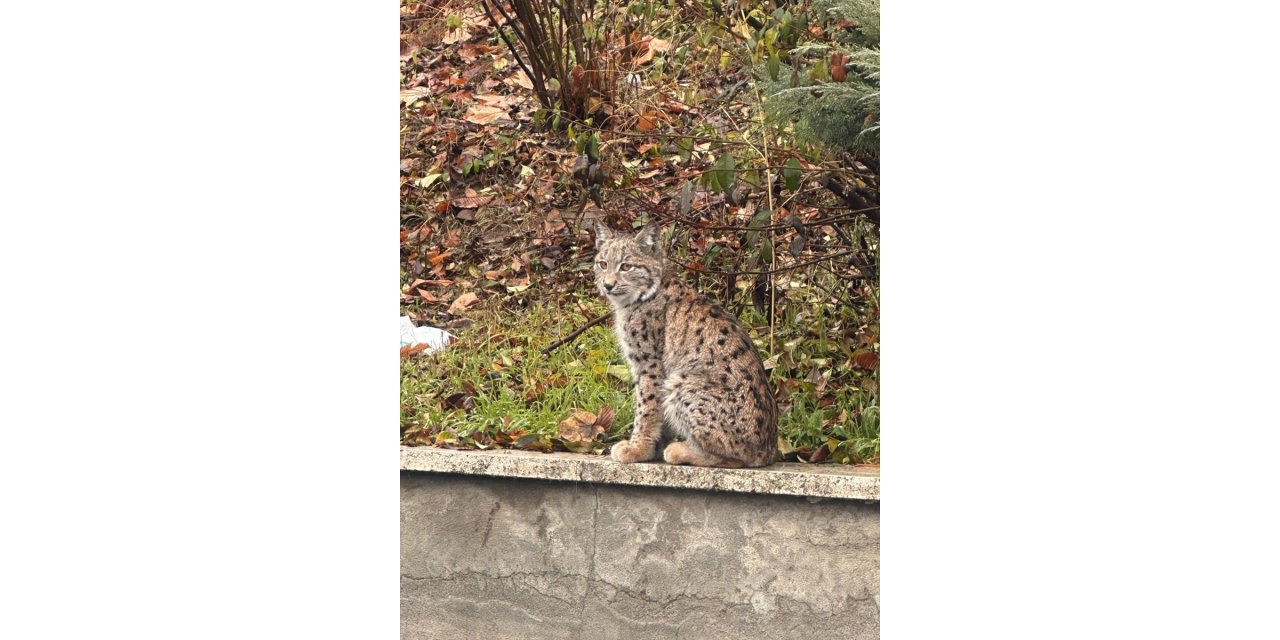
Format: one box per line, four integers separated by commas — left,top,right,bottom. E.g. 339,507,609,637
401,471,879,640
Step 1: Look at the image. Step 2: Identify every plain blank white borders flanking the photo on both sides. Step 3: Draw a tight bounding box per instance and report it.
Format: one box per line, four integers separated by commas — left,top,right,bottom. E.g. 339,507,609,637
0,0,1280,639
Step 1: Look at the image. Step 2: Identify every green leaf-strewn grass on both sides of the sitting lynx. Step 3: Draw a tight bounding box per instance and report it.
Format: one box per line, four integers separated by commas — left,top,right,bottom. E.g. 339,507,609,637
401,280,879,463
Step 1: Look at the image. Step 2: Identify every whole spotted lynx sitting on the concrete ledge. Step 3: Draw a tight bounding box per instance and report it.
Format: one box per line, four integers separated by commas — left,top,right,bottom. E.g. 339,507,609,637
595,223,778,467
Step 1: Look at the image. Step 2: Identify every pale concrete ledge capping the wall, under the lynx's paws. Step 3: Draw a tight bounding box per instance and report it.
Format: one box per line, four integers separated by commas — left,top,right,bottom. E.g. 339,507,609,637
401,447,879,502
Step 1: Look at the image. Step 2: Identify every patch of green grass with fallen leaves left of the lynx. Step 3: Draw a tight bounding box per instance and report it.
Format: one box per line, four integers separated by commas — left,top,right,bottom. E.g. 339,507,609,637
401,303,634,453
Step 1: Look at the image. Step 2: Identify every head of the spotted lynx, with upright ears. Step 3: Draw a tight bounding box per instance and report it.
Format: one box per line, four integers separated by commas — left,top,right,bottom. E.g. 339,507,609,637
595,223,666,306
